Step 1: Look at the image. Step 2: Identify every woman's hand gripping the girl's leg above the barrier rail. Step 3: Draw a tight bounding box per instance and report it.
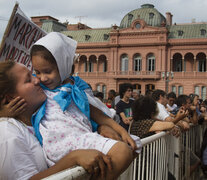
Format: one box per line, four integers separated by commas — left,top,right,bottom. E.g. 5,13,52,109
71,149,112,178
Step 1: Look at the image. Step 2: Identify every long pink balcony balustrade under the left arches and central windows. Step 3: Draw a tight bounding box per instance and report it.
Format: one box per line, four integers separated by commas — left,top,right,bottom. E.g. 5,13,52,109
78,71,161,80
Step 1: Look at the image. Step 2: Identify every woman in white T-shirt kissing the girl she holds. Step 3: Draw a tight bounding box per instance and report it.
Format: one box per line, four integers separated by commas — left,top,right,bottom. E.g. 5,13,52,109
0,61,111,179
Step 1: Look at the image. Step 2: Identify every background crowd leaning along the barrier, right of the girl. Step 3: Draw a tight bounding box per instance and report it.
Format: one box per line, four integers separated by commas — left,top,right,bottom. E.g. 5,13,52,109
96,83,207,174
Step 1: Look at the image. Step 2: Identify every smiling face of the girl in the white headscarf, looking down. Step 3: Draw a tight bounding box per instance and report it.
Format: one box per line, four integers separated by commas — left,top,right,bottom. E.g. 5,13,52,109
32,56,61,89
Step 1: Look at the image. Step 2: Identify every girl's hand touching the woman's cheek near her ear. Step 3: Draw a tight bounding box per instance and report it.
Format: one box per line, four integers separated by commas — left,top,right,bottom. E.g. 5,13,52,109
0,97,27,117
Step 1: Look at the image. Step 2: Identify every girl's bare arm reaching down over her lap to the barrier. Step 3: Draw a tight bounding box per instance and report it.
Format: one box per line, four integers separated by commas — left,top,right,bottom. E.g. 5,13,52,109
90,105,137,150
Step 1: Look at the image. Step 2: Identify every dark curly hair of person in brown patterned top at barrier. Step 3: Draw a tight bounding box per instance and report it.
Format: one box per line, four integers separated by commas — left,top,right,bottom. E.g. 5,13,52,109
132,96,157,121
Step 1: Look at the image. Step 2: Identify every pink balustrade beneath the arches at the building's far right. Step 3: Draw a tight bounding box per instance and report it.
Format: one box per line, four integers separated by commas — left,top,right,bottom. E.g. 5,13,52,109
174,71,207,79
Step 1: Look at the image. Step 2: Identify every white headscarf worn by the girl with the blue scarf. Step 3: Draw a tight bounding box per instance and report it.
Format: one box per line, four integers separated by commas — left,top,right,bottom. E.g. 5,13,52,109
34,32,77,82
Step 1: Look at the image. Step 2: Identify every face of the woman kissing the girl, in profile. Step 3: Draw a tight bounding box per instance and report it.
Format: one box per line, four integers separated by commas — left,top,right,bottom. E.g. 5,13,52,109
10,63,46,111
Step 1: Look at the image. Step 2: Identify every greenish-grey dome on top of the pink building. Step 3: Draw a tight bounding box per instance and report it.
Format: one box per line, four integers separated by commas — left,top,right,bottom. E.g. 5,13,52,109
120,4,166,28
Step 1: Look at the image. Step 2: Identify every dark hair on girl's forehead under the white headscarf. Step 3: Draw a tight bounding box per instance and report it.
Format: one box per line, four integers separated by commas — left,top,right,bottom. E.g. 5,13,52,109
30,45,57,65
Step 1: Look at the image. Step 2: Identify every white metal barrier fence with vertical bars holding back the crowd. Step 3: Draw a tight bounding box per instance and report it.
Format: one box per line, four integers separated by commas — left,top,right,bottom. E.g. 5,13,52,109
45,125,207,180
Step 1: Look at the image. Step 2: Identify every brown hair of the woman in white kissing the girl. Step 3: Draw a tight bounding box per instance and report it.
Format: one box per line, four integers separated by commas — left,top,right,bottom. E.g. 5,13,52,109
0,60,16,108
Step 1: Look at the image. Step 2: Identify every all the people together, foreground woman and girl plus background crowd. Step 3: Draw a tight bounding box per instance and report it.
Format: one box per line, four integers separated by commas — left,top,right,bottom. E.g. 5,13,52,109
0,32,207,180
